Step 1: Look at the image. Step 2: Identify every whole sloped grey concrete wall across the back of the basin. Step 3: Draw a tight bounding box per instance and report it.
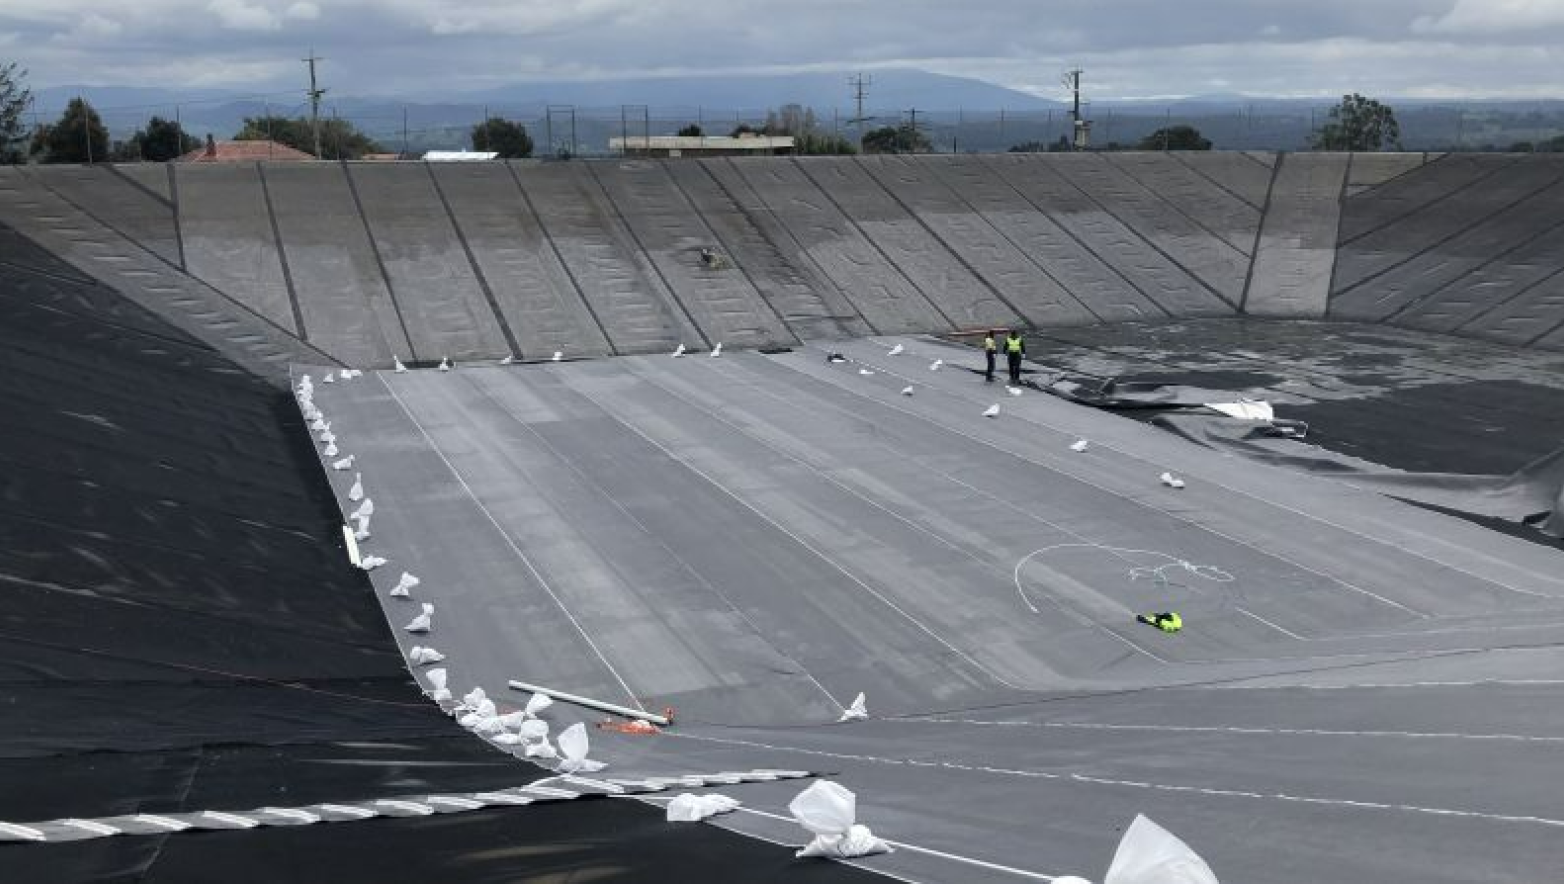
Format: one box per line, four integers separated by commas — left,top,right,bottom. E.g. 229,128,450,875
9,152,1564,366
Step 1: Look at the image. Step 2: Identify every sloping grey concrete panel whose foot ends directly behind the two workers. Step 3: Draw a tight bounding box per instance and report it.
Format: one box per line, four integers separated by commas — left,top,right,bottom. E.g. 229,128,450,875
798,156,1020,329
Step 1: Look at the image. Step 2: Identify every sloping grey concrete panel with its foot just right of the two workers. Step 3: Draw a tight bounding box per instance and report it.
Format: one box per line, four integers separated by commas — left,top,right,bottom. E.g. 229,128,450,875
860,155,1095,325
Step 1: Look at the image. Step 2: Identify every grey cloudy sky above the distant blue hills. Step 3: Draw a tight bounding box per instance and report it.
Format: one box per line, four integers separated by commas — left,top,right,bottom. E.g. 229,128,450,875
0,0,1564,97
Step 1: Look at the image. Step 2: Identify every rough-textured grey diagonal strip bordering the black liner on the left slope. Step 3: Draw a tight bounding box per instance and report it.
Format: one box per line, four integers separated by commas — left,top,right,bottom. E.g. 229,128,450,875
0,166,330,385
